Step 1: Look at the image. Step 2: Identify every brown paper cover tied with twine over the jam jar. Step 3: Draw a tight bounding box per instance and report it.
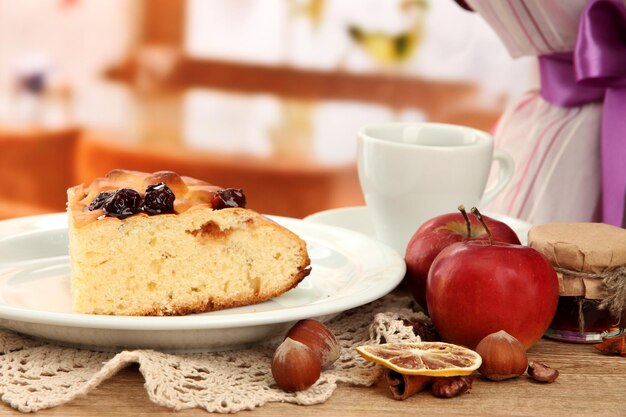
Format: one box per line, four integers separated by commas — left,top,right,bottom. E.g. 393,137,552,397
528,223,626,299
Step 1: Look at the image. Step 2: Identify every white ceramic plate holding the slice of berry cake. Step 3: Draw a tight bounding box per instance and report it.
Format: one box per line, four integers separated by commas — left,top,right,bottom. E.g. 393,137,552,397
0,213,405,352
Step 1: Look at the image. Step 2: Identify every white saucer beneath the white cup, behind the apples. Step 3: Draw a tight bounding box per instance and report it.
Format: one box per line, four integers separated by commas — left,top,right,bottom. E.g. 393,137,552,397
304,206,532,245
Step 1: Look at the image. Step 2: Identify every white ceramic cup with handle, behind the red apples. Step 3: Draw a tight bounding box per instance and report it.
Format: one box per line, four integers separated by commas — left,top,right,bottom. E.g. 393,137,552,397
357,123,514,254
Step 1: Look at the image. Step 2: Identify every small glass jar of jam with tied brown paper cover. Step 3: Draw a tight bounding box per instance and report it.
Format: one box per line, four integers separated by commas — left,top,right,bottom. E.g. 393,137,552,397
528,223,626,343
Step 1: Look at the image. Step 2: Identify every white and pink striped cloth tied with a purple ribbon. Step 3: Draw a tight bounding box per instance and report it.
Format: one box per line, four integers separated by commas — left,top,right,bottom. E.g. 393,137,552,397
468,0,602,224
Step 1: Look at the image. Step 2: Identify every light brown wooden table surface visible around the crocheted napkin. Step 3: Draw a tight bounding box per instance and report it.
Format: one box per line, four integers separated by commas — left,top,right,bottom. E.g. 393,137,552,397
0,339,626,417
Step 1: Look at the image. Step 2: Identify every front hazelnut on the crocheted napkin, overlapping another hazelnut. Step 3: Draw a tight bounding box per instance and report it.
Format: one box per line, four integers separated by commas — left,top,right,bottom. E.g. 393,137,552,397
272,337,322,391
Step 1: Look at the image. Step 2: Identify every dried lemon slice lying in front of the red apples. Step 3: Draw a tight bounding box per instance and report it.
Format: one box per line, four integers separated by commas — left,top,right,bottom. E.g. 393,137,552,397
356,342,482,376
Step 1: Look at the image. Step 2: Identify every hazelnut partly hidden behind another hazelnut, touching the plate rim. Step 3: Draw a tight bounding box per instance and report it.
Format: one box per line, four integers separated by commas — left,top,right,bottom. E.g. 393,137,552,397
287,319,341,368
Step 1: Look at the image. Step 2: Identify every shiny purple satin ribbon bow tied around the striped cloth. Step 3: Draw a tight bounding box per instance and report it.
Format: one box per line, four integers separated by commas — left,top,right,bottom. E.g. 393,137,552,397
539,0,626,226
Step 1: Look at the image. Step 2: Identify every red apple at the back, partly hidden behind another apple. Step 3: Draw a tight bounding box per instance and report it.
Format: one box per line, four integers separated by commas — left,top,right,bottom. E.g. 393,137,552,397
404,206,520,310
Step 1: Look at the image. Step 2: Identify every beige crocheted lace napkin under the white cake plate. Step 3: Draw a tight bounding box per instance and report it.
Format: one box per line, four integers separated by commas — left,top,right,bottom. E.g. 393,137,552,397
0,295,425,413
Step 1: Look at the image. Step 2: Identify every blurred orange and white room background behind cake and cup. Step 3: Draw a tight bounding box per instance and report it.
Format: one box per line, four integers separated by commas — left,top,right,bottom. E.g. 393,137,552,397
0,0,538,218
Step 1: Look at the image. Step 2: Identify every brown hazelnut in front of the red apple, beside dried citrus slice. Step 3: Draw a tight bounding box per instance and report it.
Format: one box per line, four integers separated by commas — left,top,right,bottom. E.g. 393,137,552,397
476,330,528,381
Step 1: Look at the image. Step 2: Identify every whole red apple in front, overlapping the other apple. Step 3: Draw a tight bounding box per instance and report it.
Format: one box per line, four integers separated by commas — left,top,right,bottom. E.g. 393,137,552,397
426,237,559,349
